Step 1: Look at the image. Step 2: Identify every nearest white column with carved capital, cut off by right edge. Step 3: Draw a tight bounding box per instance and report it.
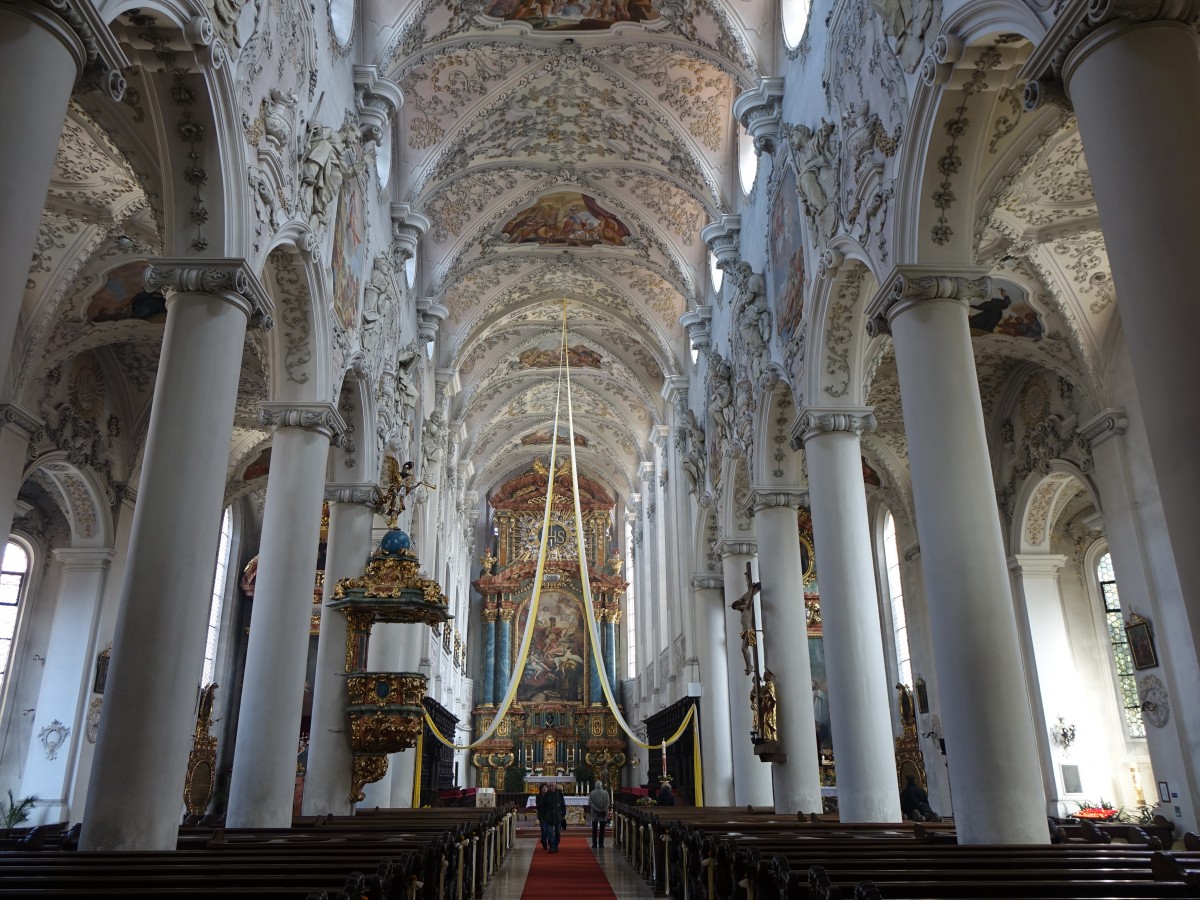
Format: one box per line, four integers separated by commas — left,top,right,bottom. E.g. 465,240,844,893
1046,10,1200,665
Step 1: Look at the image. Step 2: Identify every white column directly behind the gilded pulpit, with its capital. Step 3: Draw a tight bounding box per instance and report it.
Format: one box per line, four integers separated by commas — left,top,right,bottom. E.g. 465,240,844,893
302,484,378,816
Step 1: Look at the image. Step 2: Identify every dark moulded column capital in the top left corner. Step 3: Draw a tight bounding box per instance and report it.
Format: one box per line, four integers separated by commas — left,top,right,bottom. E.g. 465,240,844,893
2,0,130,101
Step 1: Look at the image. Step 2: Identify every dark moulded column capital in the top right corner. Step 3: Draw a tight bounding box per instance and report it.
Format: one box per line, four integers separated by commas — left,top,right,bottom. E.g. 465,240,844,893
1018,0,1200,112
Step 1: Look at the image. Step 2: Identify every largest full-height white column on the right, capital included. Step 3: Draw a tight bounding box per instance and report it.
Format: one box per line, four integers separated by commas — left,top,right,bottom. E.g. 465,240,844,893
868,273,1049,844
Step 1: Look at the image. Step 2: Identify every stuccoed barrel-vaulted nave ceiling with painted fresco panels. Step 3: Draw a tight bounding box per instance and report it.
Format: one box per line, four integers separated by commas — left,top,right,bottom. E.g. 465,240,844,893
373,0,774,493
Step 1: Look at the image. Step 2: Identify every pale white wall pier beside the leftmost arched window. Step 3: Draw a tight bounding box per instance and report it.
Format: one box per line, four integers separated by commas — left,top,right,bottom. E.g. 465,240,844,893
20,548,113,822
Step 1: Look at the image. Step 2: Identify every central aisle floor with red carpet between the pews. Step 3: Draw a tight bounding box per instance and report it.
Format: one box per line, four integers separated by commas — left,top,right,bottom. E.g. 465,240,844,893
484,828,654,900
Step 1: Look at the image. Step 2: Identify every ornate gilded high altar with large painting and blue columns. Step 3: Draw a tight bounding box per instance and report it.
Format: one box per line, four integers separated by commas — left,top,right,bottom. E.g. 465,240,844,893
472,460,628,791
